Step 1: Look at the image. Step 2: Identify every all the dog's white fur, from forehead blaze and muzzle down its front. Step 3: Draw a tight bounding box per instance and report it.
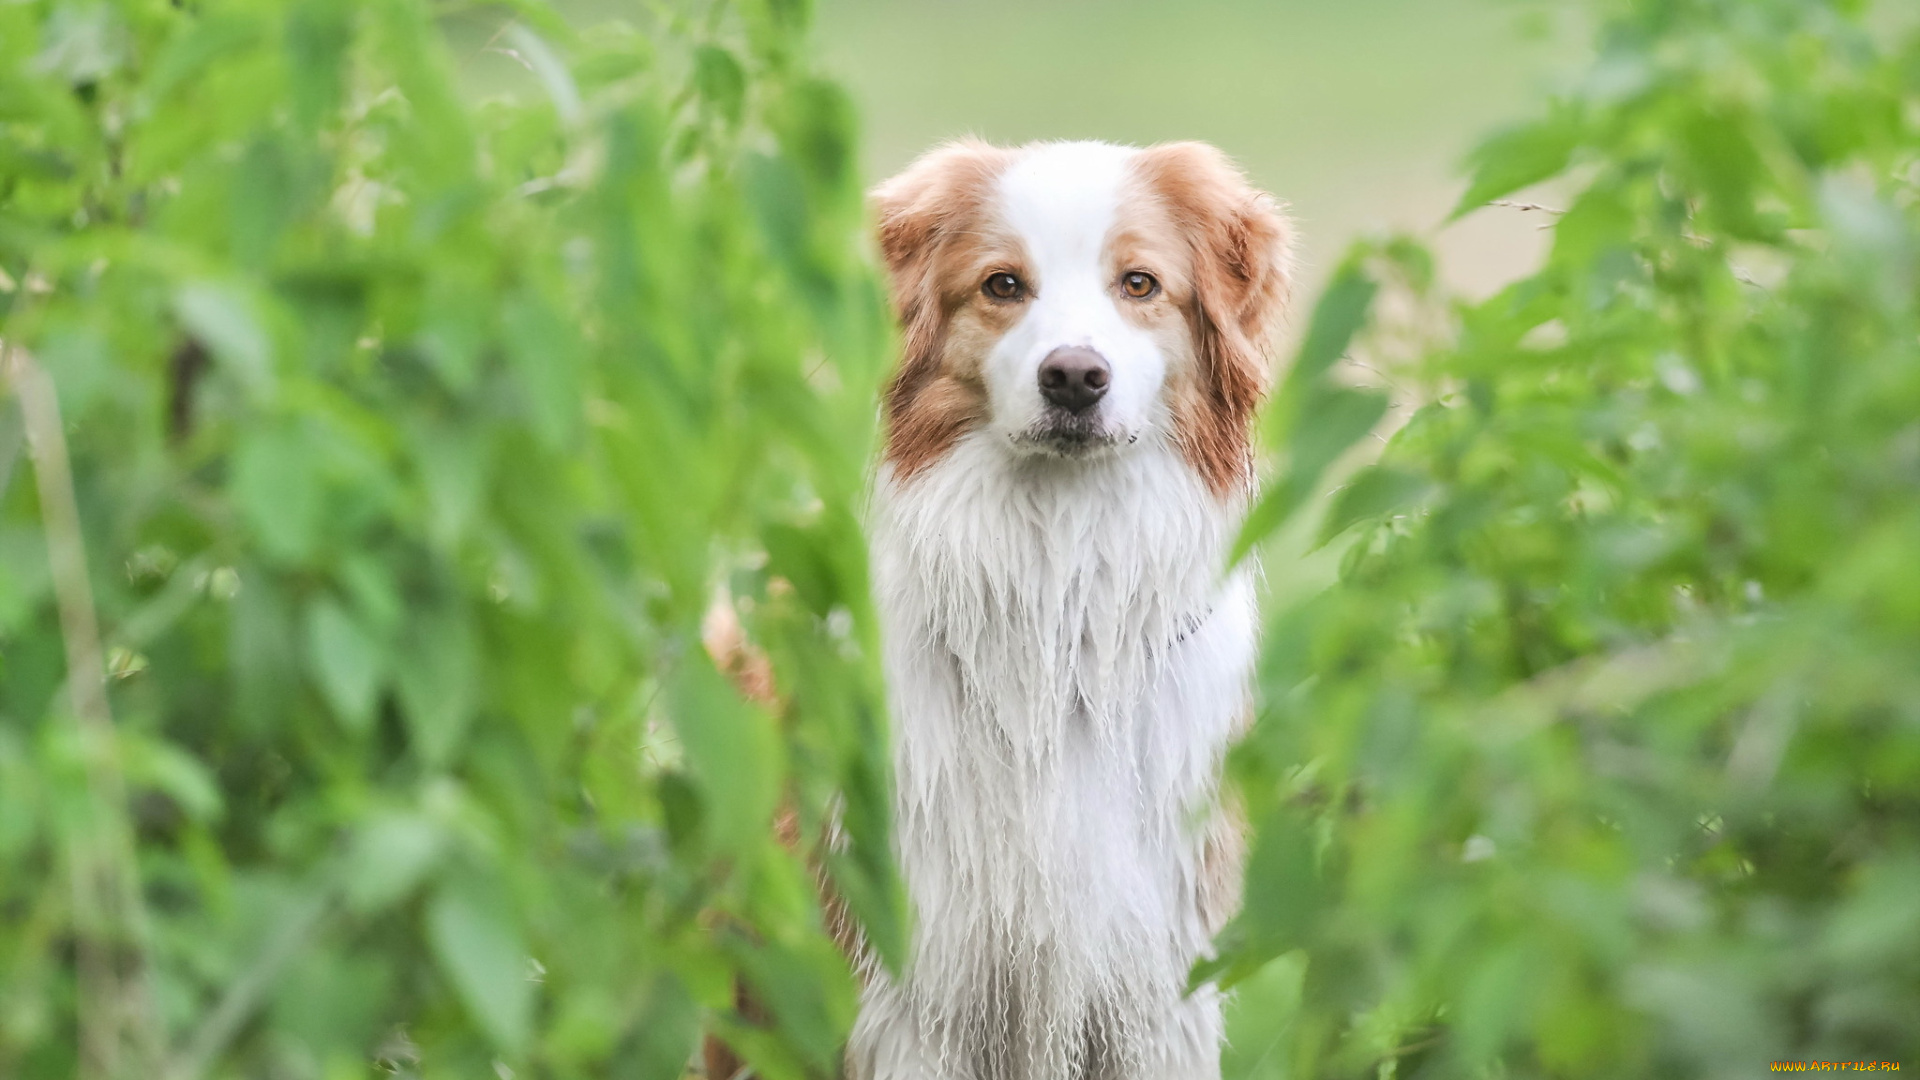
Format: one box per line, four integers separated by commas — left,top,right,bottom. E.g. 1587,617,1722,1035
849,146,1256,1080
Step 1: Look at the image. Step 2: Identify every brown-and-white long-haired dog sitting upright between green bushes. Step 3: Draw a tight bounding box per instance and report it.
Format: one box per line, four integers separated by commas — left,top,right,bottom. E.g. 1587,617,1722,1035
847,140,1292,1080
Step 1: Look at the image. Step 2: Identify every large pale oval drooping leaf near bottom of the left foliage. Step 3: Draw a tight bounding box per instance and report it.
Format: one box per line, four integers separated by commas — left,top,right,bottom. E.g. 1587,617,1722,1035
426,874,534,1055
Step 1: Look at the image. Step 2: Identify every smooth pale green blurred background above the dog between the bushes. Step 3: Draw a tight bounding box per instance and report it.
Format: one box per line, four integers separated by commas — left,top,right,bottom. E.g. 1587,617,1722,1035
816,0,1590,307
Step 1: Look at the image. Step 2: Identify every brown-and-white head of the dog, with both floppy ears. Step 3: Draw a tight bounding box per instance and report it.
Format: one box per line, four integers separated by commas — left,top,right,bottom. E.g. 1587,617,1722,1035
874,142,1288,494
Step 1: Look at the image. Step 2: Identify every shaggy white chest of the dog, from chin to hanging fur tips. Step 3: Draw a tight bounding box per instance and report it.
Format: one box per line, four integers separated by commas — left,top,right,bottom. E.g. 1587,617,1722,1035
874,438,1252,941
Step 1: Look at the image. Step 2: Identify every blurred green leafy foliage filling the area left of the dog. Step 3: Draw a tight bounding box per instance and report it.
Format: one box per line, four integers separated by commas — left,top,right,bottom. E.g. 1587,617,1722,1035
0,0,900,1080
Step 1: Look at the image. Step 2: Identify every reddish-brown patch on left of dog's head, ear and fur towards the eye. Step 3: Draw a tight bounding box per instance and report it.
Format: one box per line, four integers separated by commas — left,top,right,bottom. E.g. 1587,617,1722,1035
872,140,1018,477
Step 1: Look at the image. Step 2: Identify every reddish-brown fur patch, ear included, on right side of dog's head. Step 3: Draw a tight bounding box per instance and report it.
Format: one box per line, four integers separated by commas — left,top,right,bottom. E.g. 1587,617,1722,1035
1123,142,1292,498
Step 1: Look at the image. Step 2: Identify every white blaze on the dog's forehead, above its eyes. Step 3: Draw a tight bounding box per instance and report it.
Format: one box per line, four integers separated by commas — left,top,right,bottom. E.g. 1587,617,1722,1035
996,142,1139,274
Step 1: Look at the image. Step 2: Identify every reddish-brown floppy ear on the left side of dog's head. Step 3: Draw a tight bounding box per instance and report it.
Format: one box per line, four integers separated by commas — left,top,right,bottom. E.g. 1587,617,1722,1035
868,138,1012,473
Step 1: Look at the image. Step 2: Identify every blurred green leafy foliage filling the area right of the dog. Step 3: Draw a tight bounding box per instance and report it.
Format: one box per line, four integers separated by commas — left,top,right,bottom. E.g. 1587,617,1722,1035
1204,0,1920,1078
